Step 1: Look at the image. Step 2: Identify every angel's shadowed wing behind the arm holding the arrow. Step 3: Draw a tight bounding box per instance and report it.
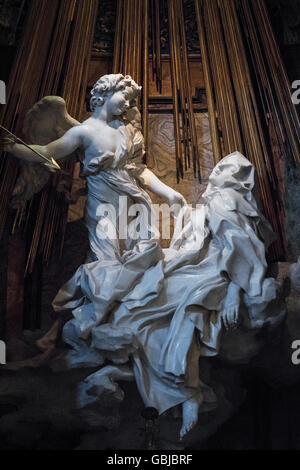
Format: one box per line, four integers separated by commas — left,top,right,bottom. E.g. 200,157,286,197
12,96,79,207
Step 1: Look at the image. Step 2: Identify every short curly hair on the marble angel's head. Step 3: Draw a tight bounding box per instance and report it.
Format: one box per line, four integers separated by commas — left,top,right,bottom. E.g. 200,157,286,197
90,73,142,111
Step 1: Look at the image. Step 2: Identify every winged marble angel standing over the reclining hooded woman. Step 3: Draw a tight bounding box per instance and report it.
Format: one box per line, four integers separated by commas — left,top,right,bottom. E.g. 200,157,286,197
4,74,185,324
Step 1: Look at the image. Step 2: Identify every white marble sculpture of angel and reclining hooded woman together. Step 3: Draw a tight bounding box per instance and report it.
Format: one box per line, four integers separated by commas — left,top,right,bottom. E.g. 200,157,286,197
2,74,285,437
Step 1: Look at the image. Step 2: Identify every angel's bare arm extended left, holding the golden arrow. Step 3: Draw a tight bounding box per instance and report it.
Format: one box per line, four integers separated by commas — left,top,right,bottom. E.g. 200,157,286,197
3,126,82,163
